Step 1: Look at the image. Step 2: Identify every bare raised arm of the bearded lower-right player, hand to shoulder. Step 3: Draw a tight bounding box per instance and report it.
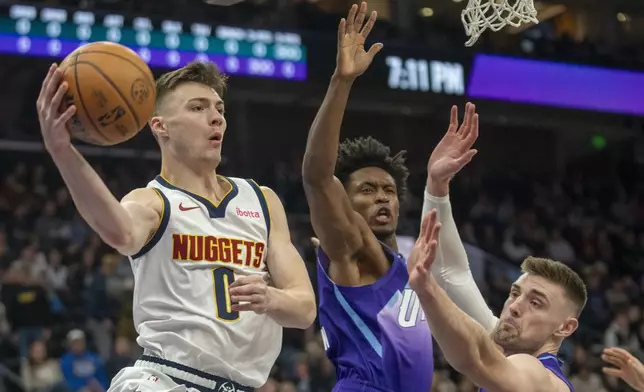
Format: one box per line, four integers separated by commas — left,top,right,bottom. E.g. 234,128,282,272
407,214,567,392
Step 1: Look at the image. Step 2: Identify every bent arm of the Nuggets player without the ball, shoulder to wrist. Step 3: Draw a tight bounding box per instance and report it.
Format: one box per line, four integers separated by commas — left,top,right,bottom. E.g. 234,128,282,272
262,187,316,329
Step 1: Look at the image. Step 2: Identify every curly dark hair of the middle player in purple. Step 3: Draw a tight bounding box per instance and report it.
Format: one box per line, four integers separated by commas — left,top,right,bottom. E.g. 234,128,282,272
335,136,409,200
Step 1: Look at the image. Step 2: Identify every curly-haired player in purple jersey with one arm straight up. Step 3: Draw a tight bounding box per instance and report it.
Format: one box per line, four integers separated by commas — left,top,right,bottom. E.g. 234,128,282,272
303,3,433,392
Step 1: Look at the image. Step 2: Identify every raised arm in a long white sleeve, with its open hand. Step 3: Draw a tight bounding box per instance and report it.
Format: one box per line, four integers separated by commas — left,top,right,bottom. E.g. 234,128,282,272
423,103,498,331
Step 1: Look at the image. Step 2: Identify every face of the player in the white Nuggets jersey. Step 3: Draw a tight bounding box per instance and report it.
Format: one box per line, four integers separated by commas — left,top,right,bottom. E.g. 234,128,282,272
155,82,226,164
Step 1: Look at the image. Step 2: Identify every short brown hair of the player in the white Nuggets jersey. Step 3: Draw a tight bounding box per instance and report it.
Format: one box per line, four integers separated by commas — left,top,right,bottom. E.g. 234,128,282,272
156,61,228,110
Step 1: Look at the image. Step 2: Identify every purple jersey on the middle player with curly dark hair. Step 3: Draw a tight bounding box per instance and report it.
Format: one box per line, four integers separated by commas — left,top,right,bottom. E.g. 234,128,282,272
317,245,434,392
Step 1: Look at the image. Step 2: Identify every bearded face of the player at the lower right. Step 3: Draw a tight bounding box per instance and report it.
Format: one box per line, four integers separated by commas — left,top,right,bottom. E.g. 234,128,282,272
492,274,578,354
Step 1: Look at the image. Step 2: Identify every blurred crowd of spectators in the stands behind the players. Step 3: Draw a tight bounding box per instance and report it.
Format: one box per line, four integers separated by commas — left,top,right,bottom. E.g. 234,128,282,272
0,148,644,392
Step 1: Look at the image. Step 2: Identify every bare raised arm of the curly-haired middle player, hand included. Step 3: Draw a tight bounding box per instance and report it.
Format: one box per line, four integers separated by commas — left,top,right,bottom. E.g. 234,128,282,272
302,3,382,261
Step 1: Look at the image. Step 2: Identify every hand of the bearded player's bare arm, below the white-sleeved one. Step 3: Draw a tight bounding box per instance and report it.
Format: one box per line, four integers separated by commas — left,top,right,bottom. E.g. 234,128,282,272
407,209,441,292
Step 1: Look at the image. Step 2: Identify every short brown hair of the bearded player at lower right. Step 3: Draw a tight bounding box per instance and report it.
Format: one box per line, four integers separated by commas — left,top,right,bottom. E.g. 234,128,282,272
521,256,588,316
